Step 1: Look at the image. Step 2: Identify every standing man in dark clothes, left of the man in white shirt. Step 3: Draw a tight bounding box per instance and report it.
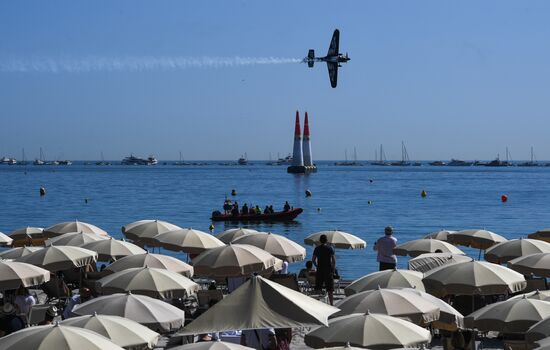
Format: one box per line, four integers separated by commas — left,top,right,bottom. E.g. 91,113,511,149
312,235,336,305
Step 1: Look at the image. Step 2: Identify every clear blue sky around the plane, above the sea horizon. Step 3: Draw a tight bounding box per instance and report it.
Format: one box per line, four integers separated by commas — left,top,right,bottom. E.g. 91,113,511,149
0,0,550,160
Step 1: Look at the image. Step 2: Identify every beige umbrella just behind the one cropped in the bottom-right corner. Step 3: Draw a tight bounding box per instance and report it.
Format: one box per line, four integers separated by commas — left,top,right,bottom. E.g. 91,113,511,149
466,297,550,333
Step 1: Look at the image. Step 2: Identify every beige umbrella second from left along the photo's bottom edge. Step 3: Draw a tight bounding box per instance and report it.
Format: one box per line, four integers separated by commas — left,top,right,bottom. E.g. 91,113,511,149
60,314,160,349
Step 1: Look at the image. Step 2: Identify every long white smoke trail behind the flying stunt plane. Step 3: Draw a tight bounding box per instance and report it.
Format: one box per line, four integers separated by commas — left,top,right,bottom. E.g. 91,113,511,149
0,56,302,73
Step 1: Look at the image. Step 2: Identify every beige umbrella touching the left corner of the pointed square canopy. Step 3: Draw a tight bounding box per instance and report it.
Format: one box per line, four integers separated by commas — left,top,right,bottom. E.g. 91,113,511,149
72,293,185,333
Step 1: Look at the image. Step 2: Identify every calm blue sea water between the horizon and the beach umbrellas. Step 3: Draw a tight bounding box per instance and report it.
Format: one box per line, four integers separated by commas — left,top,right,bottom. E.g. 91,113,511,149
0,162,550,278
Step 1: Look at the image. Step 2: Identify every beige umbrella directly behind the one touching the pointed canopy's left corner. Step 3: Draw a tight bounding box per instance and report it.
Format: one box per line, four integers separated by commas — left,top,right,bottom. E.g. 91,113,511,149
97,267,200,299
